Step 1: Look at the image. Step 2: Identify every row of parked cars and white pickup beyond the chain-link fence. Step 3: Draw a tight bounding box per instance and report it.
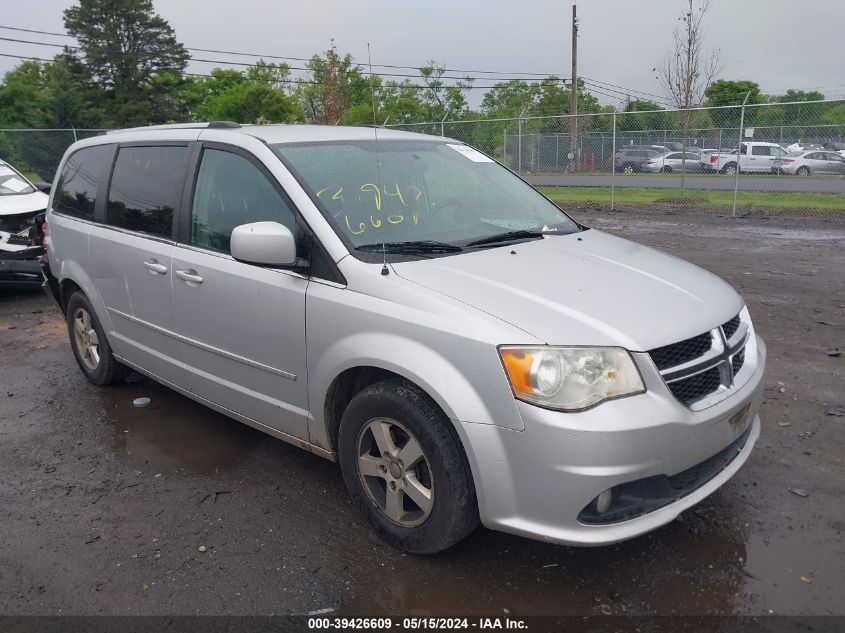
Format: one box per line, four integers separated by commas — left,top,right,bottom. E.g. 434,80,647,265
613,141,845,176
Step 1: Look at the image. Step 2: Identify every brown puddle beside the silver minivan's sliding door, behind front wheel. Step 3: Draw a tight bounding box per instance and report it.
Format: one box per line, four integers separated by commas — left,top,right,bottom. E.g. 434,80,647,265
95,375,267,474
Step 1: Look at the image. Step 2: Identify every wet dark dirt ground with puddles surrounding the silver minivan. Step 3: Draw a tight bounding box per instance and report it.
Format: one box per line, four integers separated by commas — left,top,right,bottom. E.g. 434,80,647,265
0,213,845,615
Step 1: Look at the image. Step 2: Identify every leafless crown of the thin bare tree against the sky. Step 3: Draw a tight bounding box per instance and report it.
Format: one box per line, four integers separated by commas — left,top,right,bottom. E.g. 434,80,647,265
658,0,720,109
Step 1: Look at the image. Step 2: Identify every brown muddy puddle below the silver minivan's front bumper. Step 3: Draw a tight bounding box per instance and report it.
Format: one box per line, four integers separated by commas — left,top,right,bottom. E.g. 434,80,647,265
339,523,746,615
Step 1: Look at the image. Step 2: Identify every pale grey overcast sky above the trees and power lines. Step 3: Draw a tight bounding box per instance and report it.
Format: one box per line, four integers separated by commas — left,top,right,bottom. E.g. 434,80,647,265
0,0,845,103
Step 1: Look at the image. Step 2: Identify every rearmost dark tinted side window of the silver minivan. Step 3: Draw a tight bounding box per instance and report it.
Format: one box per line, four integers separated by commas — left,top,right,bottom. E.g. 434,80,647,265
53,145,114,220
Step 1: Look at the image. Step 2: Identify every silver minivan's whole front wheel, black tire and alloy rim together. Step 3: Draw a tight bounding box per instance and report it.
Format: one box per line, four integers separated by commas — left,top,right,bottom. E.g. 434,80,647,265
338,379,478,554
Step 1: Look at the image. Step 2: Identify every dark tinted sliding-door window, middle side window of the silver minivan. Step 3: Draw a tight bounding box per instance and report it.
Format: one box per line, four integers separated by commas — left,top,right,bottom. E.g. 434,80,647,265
106,146,188,238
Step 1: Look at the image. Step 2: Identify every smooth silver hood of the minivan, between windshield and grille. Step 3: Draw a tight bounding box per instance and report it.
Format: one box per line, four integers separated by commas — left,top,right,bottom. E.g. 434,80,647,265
393,229,743,351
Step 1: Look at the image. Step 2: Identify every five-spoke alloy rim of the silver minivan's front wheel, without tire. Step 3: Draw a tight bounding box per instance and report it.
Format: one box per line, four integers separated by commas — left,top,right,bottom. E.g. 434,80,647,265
357,418,434,527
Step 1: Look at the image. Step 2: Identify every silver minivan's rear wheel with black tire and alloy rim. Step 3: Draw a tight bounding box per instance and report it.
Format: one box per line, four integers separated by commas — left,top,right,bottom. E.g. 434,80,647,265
65,291,130,385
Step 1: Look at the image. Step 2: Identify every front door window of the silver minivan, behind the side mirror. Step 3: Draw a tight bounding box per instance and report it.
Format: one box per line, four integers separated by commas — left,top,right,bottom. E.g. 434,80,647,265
191,149,296,253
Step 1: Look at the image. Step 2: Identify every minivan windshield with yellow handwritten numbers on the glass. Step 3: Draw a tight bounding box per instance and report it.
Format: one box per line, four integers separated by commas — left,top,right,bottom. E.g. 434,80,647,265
273,139,579,256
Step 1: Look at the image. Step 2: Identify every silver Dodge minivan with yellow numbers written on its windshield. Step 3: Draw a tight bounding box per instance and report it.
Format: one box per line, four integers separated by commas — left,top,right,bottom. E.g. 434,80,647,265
44,122,766,553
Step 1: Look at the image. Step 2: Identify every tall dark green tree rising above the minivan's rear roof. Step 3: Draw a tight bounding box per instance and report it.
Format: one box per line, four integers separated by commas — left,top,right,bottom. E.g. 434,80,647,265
64,0,189,126
